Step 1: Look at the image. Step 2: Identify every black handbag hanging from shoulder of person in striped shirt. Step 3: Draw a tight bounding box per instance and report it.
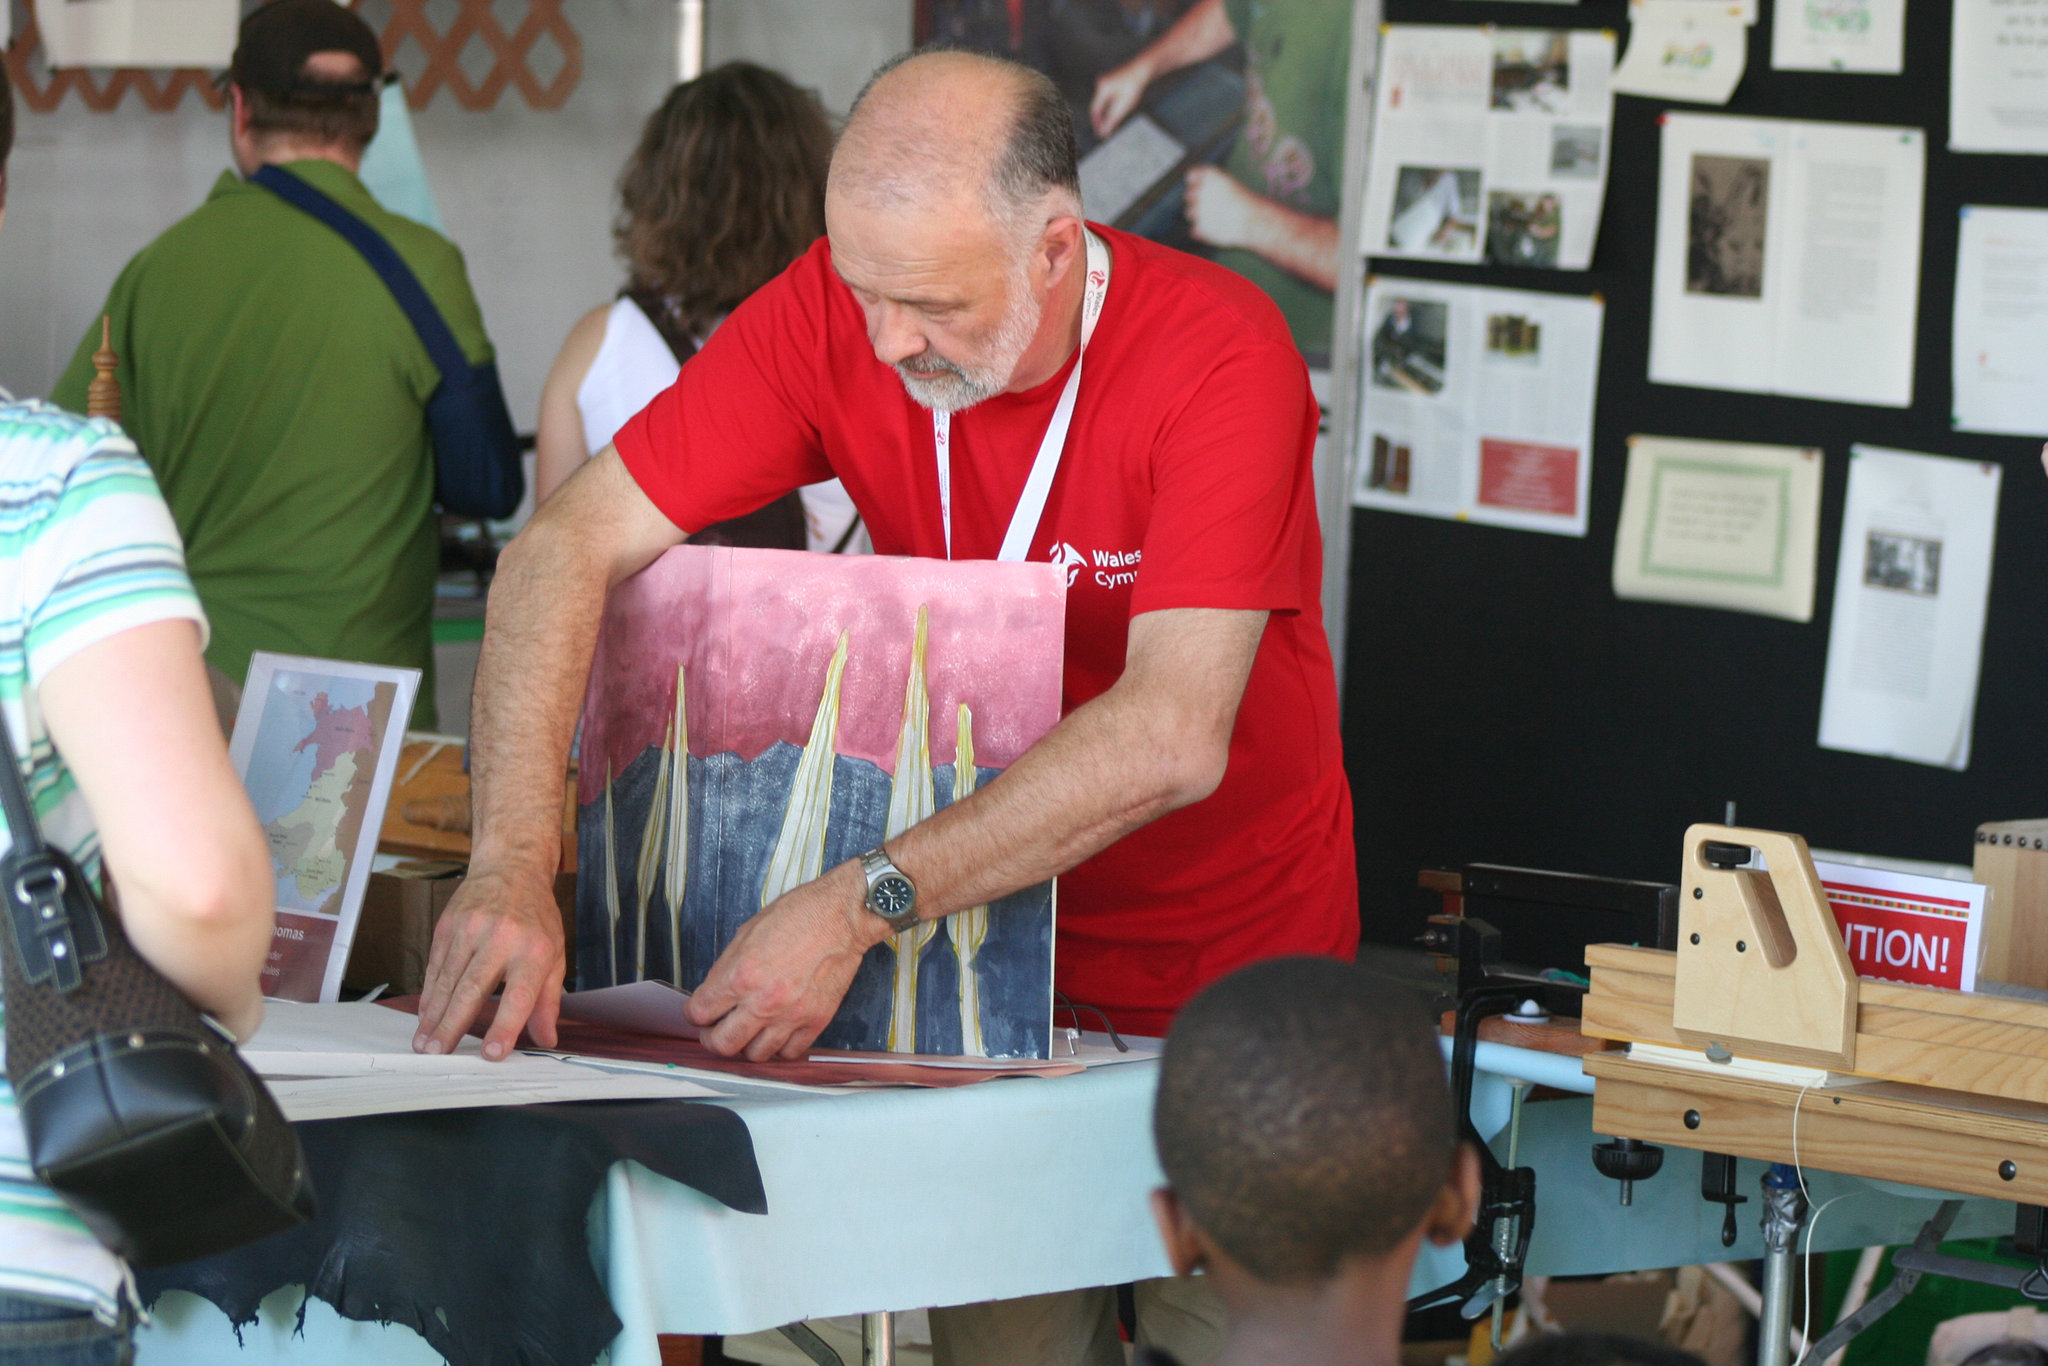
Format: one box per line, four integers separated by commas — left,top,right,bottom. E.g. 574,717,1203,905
0,721,313,1266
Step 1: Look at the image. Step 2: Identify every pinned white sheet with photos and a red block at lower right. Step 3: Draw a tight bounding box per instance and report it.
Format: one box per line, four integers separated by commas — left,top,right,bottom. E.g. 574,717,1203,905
1352,276,1606,537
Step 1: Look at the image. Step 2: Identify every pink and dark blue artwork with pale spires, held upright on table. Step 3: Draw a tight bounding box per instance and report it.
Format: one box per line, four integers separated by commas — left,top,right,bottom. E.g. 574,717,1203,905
575,545,1065,1057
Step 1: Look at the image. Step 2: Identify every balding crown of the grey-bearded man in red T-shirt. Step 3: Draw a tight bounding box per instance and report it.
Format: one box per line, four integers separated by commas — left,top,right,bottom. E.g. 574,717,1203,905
827,51,1081,246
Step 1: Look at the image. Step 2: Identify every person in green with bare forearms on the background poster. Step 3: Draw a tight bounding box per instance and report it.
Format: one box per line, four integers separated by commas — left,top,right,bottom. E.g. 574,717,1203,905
1087,0,1352,365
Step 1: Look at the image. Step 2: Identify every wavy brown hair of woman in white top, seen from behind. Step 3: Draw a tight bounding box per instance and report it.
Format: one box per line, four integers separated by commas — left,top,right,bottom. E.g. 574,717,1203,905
612,61,831,336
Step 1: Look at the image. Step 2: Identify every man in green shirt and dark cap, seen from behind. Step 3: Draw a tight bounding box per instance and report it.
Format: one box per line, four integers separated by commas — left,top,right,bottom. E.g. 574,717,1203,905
53,0,492,727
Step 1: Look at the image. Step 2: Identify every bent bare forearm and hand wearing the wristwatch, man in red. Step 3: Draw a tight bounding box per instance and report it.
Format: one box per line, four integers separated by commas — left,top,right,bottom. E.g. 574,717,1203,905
688,608,1266,1061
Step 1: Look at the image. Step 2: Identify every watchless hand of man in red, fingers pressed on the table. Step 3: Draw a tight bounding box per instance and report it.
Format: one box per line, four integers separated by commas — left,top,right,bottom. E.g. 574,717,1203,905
412,870,563,1063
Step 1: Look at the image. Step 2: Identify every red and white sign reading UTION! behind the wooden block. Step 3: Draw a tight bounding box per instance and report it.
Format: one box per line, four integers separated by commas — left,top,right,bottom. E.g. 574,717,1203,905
1812,860,1989,991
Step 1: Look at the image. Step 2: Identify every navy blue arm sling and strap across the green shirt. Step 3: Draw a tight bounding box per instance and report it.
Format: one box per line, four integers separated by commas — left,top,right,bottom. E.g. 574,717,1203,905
250,166,526,516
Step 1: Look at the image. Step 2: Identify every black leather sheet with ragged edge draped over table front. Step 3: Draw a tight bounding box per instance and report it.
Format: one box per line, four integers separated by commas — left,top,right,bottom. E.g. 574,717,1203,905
137,1100,768,1366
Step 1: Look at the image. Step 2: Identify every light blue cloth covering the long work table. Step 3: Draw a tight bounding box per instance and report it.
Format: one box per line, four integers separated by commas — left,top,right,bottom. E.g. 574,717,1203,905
137,1042,2011,1366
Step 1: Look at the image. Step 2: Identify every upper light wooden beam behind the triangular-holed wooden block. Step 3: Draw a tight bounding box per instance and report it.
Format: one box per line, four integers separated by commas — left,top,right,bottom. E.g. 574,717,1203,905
1581,944,2048,1104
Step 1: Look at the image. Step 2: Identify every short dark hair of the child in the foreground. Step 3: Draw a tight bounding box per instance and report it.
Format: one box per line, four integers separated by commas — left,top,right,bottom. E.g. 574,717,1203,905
1153,958,1456,1284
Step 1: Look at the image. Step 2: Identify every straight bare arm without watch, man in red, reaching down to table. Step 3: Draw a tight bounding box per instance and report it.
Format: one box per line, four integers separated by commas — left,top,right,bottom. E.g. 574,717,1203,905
414,446,684,1059
